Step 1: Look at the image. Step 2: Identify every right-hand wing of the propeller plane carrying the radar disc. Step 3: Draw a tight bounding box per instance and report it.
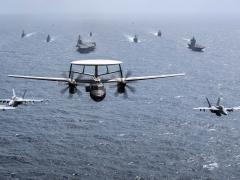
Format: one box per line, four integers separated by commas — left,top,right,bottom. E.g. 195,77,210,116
106,73,185,83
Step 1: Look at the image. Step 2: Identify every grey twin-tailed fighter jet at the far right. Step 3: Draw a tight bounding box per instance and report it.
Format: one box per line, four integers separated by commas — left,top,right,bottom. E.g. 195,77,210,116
193,98,240,116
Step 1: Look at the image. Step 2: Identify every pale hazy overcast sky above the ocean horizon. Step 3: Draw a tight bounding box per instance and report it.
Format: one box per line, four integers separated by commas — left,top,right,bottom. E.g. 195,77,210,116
0,0,240,16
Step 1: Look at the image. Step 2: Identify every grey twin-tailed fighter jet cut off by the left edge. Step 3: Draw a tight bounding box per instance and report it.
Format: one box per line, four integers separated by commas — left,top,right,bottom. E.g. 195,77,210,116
0,89,43,107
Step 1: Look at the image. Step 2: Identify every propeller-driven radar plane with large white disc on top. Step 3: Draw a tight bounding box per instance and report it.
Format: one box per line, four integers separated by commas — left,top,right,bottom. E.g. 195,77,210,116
8,59,185,102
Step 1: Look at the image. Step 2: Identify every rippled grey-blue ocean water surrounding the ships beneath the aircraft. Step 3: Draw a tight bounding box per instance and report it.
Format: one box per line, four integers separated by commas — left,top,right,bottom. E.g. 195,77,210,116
0,16,240,180
